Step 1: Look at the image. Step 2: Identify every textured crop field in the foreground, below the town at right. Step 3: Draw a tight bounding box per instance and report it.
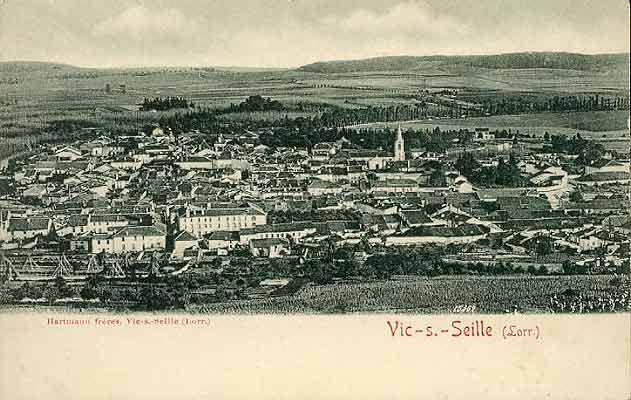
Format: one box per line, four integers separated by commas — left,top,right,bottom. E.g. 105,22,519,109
193,276,629,314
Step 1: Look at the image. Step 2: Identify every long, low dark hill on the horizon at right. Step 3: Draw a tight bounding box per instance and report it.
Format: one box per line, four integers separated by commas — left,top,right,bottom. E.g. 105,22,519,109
298,52,629,73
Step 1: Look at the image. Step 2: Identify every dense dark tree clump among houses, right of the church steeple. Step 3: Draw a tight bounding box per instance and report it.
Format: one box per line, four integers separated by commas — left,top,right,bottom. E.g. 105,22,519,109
455,153,524,187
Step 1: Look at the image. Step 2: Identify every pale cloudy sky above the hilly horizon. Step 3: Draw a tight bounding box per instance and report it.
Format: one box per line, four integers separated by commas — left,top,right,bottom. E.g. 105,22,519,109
0,0,629,67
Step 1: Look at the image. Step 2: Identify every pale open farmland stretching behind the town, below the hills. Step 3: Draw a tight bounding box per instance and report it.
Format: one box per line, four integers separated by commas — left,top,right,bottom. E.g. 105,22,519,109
0,63,629,159
